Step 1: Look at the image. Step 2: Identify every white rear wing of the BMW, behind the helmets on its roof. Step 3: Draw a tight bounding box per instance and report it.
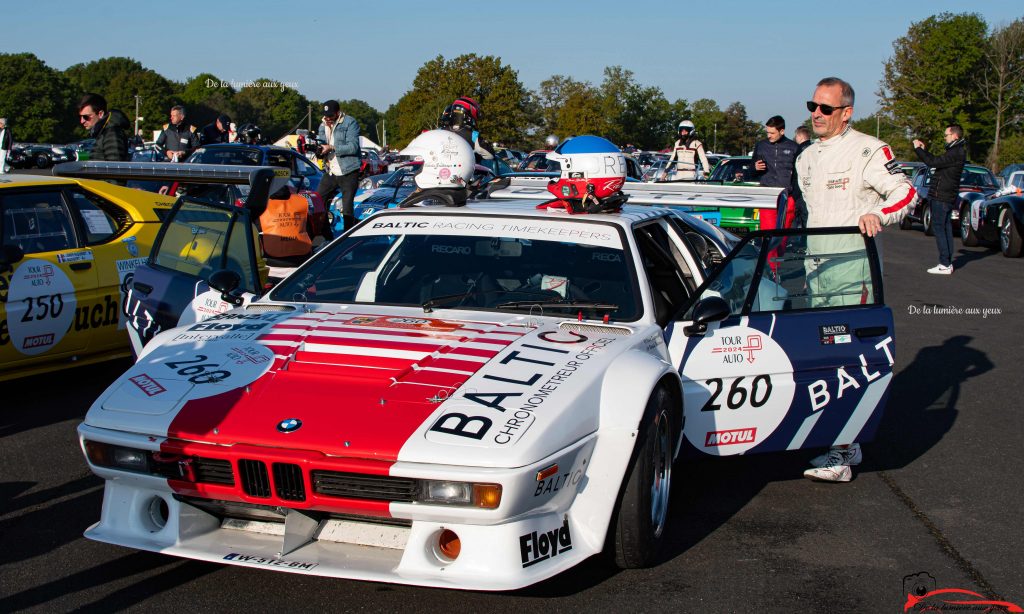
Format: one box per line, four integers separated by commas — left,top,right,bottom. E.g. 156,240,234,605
488,173,788,213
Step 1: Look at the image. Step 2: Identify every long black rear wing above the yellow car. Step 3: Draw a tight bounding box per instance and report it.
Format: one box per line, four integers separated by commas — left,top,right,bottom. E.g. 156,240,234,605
53,162,292,207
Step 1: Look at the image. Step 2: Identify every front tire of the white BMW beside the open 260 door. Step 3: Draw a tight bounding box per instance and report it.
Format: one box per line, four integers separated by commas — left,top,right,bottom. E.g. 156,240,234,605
608,387,679,569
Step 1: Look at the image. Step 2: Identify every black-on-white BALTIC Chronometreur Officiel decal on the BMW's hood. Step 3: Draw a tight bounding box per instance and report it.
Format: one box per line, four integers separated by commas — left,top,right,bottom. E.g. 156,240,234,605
427,331,616,446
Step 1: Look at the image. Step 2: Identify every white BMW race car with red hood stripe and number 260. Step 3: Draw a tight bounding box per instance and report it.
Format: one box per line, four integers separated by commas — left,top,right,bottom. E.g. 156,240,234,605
79,201,895,590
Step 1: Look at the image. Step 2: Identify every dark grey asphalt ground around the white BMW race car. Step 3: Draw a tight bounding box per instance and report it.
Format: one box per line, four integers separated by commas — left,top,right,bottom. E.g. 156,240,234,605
0,217,1024,612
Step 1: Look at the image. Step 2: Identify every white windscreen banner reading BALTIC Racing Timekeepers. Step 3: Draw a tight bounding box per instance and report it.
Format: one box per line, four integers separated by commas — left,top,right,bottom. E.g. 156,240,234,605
353,215,623,249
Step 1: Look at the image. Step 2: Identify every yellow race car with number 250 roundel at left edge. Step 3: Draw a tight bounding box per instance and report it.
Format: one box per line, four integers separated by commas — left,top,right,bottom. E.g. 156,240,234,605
0,175,175,381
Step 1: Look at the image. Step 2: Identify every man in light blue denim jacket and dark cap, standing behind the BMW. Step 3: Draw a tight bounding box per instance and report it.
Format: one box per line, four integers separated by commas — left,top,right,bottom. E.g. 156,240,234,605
316,100,361,230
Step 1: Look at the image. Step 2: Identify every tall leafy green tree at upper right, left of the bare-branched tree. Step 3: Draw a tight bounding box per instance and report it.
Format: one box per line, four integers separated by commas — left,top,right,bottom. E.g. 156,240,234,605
879,12,992,158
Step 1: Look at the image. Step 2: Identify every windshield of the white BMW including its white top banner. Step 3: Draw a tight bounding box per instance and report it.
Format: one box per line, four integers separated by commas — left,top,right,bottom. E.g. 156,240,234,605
270,214,641,320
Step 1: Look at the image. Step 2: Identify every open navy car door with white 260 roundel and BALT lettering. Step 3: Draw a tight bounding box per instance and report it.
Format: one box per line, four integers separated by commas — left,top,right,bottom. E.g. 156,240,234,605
667,227,896,456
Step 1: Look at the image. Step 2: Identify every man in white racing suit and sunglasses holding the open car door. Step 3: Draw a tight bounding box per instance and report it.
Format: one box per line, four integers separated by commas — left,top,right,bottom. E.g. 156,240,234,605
797,77,918,482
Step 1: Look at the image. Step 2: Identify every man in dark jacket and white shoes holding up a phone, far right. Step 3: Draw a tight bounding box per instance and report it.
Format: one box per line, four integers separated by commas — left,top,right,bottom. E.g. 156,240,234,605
913,124,967,275
